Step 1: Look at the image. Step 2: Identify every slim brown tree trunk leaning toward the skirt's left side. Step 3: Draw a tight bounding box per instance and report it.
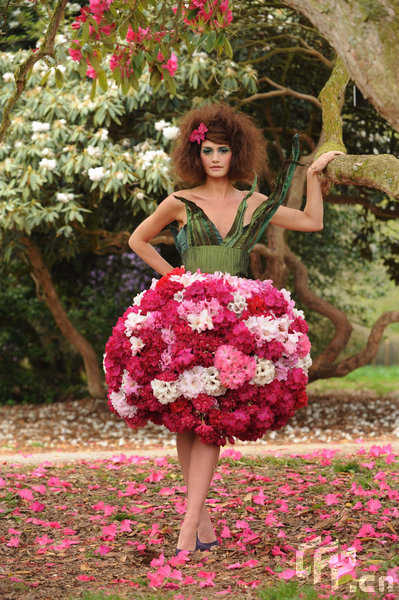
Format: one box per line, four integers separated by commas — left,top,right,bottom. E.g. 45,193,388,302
21,236,106,398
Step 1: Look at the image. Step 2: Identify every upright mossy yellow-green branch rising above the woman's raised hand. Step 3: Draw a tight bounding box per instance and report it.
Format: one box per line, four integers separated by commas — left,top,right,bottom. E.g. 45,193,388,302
317,58,349,156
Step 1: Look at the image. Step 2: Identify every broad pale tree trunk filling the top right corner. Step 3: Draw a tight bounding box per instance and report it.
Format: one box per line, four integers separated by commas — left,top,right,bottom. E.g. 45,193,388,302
283,0,399,131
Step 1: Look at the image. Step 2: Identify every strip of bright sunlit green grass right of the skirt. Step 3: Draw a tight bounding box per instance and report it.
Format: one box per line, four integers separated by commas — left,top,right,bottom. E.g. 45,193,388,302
308,365,399,396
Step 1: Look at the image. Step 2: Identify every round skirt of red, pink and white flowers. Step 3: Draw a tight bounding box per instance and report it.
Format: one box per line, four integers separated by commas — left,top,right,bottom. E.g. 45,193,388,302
104,268,312,445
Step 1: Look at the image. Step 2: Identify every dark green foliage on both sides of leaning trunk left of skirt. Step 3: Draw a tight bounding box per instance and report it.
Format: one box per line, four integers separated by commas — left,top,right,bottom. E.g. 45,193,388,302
0,248,155,404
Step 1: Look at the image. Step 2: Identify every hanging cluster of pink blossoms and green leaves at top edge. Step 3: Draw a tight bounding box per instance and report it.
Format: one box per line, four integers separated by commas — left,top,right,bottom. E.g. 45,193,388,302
69,0,233,95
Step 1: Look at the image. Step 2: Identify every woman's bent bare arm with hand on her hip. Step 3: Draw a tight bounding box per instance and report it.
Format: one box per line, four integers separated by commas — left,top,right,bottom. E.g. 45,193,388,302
128,195,183,275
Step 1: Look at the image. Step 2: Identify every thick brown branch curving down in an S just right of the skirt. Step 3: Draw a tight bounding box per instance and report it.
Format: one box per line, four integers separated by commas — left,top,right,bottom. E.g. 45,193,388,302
284,241,352,368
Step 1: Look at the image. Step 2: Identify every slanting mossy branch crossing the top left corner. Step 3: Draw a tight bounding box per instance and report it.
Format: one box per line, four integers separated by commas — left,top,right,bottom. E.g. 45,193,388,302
0,0,68,143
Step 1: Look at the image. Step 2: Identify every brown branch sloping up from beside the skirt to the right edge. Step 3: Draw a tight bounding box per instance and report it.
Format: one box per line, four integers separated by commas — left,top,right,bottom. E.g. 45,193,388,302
310,311,399,380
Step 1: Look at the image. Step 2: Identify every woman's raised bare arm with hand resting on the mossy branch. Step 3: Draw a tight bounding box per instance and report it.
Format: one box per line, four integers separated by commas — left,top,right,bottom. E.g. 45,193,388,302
270,150,344,231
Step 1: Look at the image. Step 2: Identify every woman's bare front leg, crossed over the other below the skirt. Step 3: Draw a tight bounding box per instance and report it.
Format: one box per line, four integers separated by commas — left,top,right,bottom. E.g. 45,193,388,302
177,434,220,550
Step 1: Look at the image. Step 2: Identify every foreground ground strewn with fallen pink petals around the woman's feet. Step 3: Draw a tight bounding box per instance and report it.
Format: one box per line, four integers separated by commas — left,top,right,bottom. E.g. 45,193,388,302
0,445,399,600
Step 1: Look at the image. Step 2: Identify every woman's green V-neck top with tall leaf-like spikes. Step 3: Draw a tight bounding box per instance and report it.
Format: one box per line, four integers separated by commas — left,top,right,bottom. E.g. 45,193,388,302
170,135,299,277
